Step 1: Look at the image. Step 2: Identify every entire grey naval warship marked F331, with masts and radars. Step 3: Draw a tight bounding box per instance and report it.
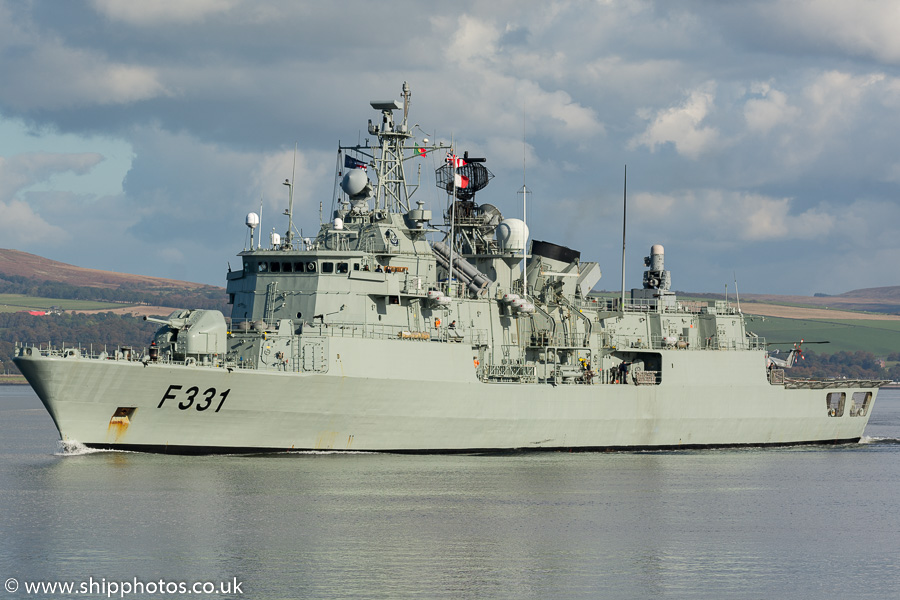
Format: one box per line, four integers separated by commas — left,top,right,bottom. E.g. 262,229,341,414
15,83,886,453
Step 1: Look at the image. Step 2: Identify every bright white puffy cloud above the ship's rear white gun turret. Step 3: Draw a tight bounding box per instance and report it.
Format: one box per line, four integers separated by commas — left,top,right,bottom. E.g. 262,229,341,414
629,82,719,160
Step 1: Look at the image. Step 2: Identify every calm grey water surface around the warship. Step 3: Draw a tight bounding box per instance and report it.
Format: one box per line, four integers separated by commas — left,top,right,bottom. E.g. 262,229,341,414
0,386,900,600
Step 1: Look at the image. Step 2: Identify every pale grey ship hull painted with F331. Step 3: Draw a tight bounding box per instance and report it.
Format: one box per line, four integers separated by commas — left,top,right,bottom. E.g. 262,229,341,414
16,339,876,453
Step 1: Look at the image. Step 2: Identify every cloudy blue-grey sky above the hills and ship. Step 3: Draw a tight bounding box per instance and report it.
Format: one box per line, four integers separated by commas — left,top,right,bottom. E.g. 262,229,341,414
0,0,900,295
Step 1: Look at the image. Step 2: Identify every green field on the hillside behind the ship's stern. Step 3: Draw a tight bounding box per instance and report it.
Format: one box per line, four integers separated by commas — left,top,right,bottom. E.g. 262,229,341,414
747,316,900,356
